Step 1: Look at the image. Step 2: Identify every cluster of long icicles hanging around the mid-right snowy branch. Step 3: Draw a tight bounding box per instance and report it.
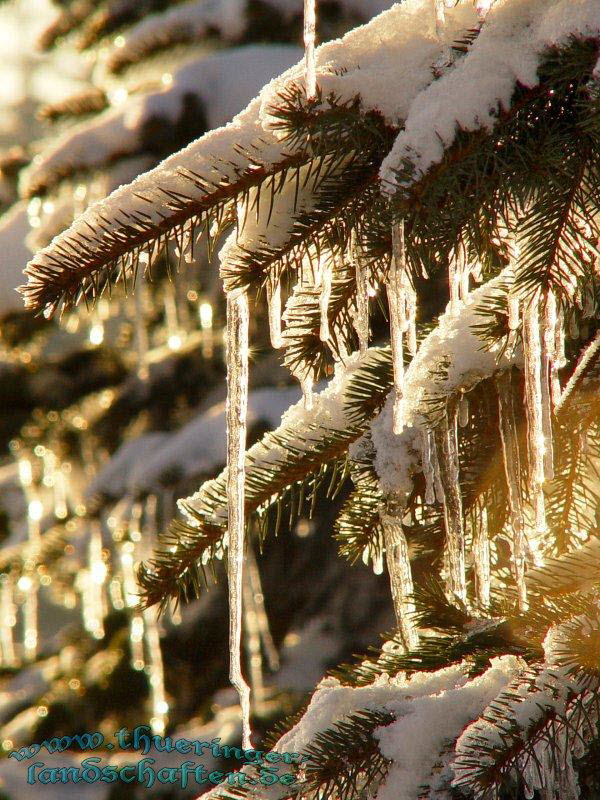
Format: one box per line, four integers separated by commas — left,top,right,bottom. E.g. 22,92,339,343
381,223,567,664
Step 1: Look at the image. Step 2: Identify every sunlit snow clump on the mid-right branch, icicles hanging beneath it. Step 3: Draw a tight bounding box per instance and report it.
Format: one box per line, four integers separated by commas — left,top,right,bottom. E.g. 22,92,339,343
371,272,522,495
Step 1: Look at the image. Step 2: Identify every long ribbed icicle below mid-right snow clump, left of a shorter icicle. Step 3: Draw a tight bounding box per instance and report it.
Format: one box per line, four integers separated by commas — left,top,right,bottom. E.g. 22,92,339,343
434,402,467,602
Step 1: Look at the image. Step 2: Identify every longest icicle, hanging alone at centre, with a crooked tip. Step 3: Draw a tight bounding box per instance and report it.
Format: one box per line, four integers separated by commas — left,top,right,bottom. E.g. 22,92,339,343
227,292,252,749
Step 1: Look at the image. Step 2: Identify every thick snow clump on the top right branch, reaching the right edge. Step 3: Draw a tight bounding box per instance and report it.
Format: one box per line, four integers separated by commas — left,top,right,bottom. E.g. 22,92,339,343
380,0,600,190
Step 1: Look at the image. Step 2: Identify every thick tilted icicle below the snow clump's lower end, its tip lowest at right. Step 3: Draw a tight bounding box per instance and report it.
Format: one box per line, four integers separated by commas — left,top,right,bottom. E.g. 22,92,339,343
380,498,419,650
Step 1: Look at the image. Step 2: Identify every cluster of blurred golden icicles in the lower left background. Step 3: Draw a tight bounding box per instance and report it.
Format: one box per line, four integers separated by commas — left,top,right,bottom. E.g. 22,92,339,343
0,446,173,735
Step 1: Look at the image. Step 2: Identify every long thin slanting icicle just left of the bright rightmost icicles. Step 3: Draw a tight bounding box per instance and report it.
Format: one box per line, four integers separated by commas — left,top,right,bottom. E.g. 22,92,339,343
496,372,528,611
